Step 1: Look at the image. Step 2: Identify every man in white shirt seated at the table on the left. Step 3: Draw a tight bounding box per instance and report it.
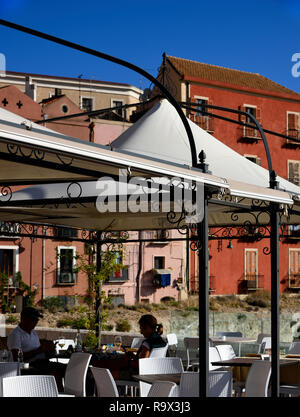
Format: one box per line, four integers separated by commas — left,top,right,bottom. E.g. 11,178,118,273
7,307,66,392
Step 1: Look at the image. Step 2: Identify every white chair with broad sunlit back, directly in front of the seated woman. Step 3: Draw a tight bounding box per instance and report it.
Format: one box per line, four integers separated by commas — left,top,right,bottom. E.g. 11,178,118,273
139,358,183,397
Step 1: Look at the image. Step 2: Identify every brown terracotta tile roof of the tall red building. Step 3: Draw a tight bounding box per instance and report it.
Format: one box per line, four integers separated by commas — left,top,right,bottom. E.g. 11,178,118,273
167,56,300,98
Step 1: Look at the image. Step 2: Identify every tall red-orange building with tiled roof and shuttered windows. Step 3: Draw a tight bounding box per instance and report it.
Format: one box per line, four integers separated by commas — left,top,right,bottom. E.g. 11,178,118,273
159,56,300,294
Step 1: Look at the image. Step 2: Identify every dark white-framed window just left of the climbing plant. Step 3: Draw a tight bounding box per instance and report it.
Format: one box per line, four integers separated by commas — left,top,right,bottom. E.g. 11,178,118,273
57,246,77,285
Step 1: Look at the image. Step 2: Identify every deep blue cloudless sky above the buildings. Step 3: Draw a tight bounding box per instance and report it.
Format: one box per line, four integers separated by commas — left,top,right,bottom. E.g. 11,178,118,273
0,0,300,93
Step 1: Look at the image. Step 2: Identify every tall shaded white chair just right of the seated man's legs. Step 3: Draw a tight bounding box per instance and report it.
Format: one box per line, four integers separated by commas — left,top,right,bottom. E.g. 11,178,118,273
64,352,92,397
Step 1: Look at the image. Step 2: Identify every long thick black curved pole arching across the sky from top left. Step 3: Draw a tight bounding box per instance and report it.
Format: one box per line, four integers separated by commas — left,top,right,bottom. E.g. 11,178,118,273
0,19,198,168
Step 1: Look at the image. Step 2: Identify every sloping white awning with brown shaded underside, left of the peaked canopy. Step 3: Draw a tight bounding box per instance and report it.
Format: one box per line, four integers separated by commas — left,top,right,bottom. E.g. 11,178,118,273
0,108,228,188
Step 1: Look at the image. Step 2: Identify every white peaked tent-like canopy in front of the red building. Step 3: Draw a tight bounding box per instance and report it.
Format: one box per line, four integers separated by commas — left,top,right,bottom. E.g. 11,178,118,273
111,99,300,199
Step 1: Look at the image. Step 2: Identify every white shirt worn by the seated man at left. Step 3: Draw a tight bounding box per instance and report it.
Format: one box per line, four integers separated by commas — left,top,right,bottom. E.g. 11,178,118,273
7,326,46,362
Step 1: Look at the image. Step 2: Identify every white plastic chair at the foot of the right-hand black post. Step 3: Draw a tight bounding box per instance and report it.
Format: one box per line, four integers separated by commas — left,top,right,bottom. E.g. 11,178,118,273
245,360,271,397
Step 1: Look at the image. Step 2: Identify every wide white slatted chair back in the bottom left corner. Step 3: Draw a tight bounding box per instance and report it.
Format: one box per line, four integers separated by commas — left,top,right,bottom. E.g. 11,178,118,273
2,375,58,397
